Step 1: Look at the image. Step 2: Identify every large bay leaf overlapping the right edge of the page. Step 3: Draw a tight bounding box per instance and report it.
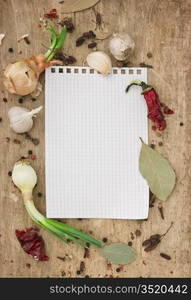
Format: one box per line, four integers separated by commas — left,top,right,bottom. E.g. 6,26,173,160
139,142,176,200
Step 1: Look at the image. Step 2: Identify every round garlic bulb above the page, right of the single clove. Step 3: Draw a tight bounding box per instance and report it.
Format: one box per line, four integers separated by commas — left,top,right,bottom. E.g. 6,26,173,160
109,32,135,61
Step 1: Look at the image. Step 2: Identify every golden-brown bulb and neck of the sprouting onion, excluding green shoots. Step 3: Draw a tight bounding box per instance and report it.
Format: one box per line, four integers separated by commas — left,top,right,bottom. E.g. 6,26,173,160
3,53,61,96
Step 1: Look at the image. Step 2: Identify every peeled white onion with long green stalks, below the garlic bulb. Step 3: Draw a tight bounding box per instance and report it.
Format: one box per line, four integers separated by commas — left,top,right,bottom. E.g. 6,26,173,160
12,161,103,248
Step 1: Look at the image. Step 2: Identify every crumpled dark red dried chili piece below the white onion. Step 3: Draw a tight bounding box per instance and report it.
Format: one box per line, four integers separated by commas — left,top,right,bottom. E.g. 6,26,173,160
15,228,49,261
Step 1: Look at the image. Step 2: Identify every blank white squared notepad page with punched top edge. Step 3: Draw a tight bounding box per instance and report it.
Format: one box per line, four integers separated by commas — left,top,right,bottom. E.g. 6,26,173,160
45,67,149,219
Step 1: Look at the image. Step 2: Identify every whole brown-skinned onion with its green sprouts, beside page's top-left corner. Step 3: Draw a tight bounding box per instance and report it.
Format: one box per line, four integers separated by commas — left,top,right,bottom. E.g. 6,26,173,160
3,26,67,96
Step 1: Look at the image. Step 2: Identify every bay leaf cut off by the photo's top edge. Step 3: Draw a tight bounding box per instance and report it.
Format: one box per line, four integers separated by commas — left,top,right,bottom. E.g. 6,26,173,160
62,0,100,13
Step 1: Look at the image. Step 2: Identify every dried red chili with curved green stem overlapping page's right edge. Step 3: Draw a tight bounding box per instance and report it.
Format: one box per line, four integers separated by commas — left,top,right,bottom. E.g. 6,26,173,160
126,80,174,131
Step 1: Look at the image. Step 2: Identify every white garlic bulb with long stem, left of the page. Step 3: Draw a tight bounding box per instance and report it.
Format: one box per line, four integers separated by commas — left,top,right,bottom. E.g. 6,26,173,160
8,106,42,133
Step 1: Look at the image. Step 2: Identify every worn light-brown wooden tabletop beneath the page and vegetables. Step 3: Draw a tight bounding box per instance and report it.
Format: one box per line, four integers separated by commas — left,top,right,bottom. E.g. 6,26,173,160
0,0,191,277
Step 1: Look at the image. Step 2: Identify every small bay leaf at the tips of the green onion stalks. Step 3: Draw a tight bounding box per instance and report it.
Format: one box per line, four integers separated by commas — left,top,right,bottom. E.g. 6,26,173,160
100,243,137,265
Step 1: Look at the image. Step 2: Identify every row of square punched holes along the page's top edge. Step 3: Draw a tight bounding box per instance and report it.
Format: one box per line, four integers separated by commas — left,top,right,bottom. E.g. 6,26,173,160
51,66,142,75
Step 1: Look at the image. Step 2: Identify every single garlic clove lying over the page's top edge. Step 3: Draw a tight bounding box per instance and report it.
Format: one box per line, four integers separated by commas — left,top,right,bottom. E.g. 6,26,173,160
86,51,112,75
